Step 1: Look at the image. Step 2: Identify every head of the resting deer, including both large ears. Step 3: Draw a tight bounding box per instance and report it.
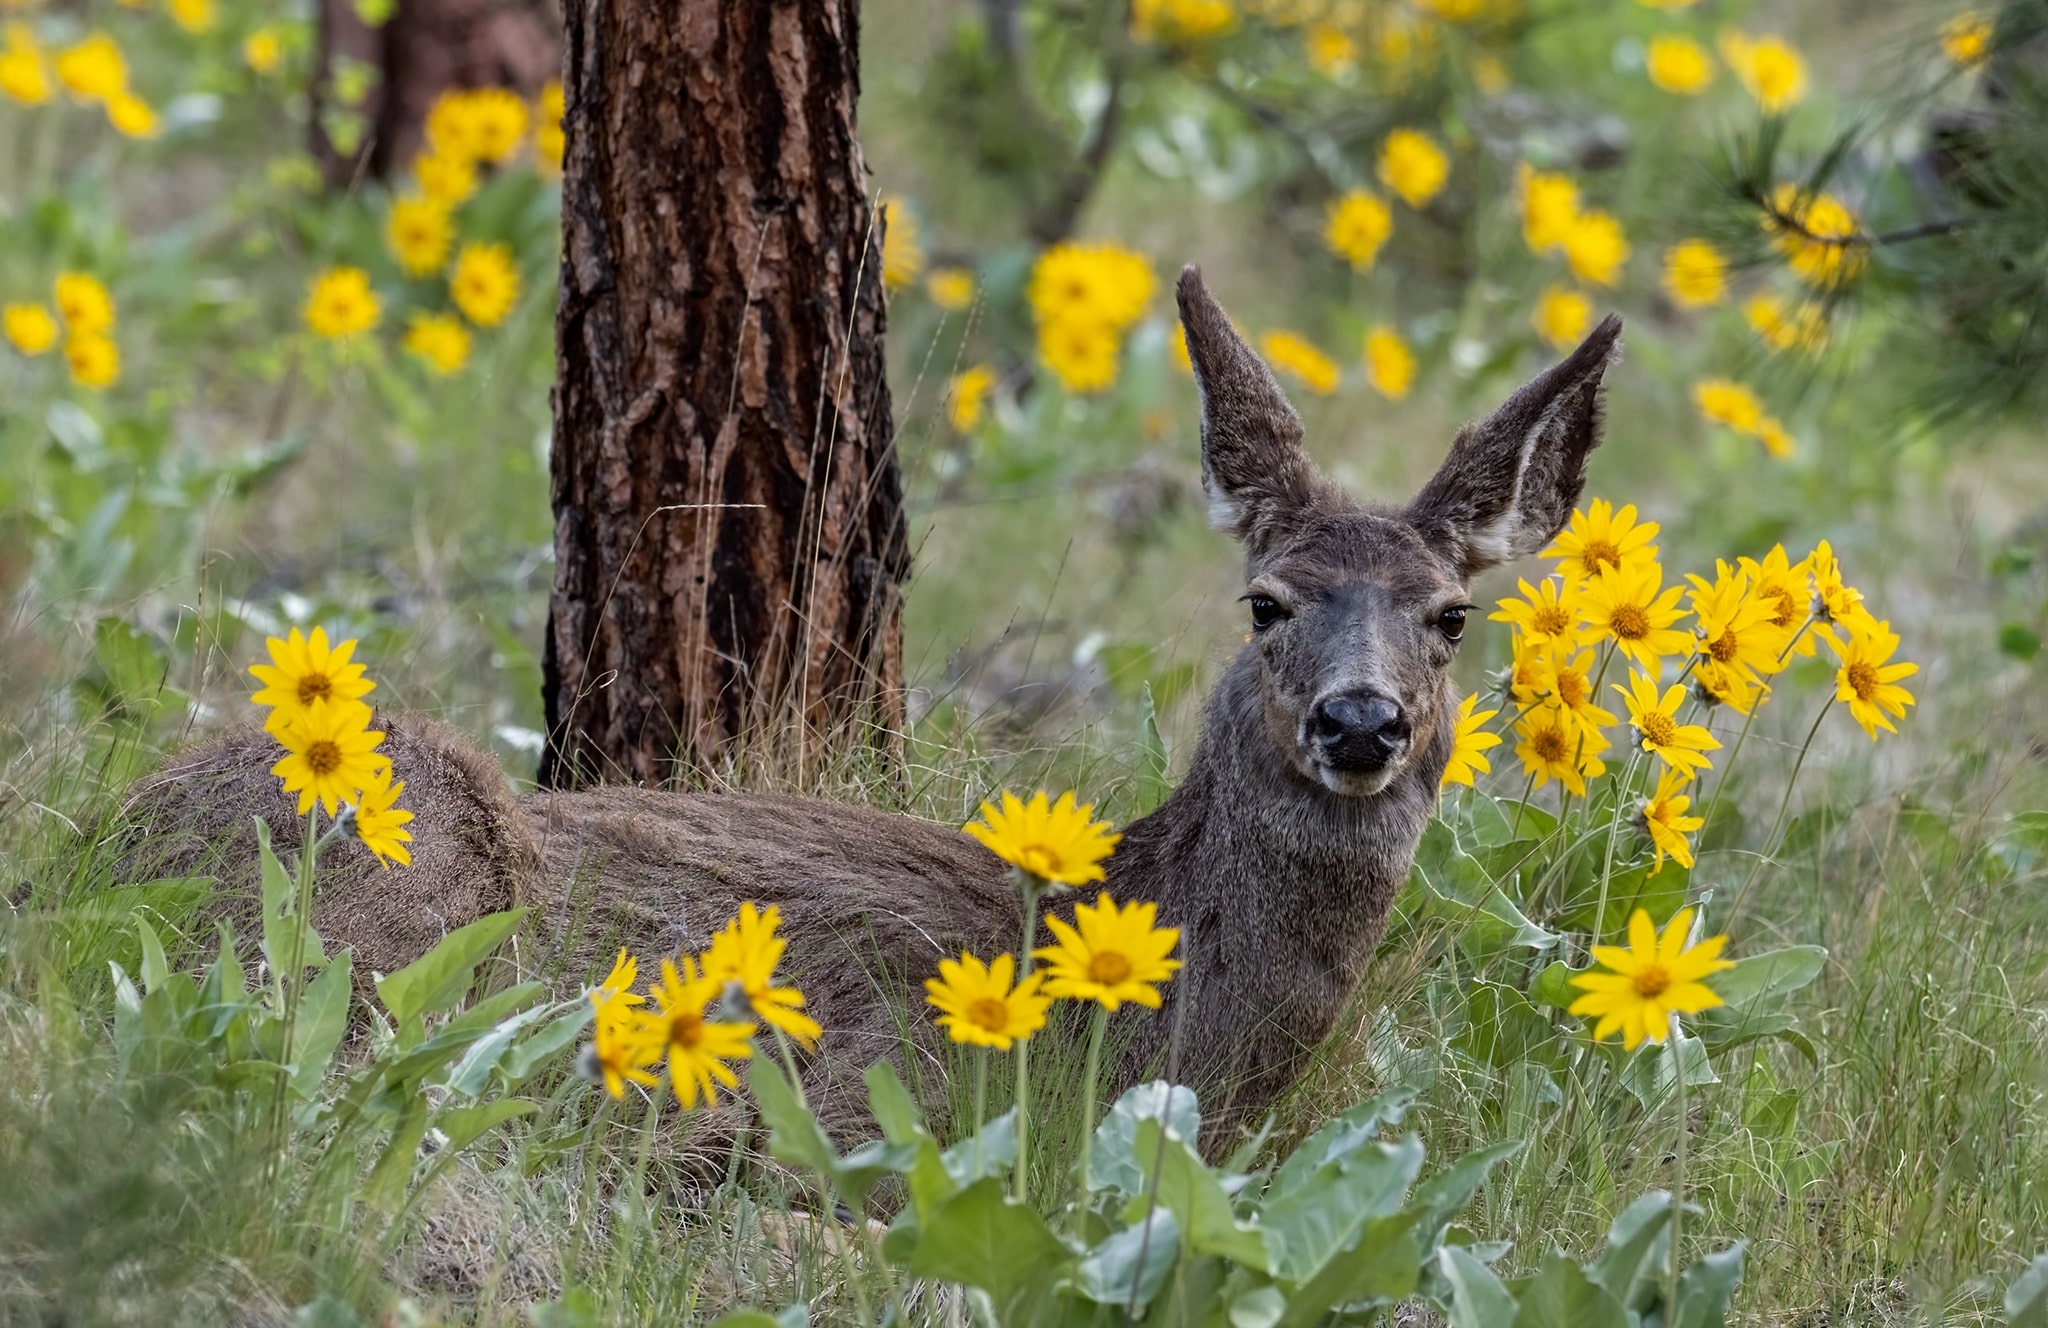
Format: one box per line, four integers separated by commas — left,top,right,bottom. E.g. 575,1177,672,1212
1180,266,1622,797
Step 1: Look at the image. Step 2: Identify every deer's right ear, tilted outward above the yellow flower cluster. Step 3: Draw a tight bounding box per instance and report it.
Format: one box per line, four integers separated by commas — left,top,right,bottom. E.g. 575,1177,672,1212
1407,314,1622,578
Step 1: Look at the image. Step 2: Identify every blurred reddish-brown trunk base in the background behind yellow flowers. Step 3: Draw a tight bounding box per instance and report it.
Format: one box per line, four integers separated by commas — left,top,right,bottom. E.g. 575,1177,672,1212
313,0,561,189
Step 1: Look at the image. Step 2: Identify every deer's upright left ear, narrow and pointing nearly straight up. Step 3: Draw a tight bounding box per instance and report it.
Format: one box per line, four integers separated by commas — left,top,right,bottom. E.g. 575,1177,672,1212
1180,264,1337,553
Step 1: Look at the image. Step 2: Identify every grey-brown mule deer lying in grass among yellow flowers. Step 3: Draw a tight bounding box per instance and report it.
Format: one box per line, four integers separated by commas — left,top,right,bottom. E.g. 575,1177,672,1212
133,266,1620,1121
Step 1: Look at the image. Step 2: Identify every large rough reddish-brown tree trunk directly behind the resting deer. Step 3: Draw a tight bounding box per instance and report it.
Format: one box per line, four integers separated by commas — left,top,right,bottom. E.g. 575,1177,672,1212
541,0,909,787
